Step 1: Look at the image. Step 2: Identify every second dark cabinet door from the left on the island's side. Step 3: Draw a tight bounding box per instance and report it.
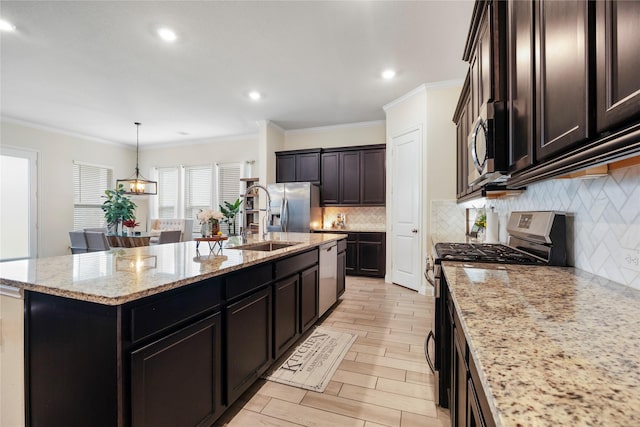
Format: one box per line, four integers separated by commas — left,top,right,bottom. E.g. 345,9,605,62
225,286,273,405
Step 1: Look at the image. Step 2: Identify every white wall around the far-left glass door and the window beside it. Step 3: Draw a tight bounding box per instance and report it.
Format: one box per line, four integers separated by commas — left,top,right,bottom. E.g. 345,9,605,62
0,120,135,258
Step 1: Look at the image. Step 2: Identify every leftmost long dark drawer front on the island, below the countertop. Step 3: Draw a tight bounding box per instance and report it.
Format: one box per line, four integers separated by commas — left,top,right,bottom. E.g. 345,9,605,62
128,279,222,343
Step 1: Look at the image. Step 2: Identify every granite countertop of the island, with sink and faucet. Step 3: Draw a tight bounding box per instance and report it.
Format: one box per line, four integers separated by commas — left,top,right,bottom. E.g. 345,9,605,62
0,233,344,305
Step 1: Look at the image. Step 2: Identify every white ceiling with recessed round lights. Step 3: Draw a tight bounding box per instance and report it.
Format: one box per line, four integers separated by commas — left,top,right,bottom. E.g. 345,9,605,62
0,0,473,146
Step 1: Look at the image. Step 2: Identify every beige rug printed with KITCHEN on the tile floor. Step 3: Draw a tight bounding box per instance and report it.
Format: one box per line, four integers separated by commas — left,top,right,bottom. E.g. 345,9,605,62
264,327,357,393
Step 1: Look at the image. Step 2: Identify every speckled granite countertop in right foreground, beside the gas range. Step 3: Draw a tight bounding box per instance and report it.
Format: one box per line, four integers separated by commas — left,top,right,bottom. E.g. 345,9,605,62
443,262,640,426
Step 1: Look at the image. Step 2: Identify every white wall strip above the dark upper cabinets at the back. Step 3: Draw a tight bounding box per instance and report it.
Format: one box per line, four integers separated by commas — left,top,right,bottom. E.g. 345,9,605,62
282,121,386,150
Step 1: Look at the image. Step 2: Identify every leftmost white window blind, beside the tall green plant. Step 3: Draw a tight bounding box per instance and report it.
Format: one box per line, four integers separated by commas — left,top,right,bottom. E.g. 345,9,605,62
73,162,113,230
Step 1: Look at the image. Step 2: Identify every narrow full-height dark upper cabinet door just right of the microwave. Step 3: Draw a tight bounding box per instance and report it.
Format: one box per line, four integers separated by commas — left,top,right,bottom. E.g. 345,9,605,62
507,0,534,172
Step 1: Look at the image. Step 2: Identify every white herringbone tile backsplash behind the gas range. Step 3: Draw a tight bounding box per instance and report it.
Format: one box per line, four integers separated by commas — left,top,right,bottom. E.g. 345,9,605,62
430,166,640,289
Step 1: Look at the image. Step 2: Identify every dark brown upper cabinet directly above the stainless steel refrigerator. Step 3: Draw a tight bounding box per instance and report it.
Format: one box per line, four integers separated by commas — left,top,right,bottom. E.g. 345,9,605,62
276,149,320,183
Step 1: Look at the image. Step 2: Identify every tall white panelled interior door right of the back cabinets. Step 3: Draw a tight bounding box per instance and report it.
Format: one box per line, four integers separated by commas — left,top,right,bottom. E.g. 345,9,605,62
391,129,421,291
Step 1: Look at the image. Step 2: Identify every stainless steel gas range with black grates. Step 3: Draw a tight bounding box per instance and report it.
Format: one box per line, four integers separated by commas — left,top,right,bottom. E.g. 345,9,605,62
425,211,567,408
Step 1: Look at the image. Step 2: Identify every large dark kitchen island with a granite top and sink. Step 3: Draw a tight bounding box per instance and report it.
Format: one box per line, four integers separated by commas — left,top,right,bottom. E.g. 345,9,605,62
0,233,344,426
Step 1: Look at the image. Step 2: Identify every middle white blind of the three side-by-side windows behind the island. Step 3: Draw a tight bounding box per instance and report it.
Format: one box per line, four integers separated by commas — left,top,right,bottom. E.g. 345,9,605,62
184,165,213,232
